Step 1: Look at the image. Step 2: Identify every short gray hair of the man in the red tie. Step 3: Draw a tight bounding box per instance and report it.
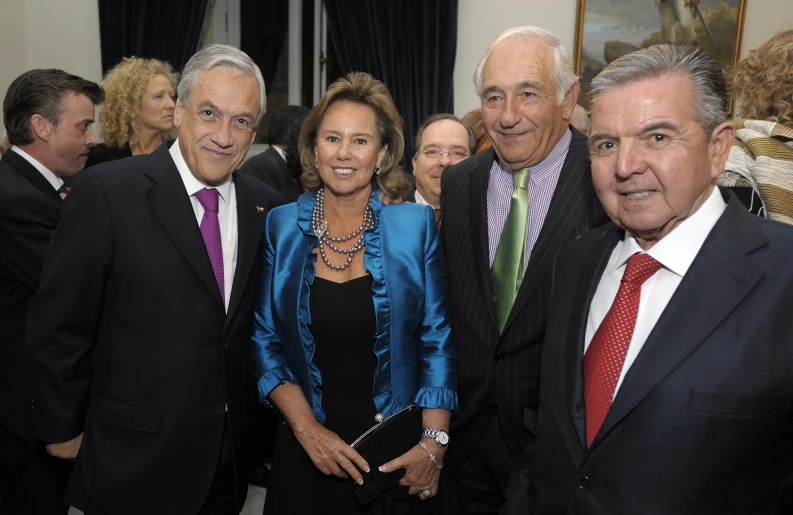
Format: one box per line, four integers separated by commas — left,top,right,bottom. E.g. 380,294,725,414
590,43,727,134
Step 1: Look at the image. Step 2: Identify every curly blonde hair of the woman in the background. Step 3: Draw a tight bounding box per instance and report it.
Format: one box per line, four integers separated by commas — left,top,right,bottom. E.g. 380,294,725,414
99,57,177,148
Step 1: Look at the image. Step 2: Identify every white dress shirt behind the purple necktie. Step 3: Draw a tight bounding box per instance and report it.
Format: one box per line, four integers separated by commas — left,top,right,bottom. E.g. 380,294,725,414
170,139,237,311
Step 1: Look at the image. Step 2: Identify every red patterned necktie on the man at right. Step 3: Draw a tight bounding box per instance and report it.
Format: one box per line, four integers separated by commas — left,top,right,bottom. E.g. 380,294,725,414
584,254,661,447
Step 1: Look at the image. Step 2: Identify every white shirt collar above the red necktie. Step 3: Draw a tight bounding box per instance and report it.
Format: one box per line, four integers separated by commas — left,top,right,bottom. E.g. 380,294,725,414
609,187,727,277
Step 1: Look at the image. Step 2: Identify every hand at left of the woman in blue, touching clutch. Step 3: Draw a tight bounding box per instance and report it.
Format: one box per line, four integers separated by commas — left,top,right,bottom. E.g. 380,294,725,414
294,423,369,485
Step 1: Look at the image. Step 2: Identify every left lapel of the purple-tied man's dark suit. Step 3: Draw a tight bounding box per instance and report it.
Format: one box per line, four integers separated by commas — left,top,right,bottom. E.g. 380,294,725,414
145,144,225,310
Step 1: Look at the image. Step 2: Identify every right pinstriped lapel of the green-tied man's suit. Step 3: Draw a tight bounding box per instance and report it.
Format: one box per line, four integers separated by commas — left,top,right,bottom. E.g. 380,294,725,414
504,131,595,333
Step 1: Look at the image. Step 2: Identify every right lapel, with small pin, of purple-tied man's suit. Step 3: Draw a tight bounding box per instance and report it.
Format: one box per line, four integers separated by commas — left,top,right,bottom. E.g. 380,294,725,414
226,172,266,324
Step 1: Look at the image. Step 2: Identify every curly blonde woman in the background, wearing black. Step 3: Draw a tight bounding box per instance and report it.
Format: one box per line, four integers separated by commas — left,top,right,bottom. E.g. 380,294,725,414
85,57,177,168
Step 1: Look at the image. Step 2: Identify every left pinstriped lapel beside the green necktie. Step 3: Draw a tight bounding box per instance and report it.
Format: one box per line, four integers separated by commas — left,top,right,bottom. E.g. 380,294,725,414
468,148,498,327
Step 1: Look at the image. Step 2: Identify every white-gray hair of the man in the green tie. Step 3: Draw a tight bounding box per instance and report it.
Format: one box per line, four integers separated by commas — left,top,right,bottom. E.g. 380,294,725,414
474,25,578,105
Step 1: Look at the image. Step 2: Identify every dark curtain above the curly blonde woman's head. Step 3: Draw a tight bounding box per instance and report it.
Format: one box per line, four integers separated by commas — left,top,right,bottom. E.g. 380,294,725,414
98,0,208,74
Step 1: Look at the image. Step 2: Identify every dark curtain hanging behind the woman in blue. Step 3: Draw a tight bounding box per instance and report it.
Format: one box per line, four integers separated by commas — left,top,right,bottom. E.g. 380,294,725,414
325,0,457,173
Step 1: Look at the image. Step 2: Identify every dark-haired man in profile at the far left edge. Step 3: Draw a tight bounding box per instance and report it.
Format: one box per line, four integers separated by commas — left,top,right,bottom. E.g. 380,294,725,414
0,70,104,515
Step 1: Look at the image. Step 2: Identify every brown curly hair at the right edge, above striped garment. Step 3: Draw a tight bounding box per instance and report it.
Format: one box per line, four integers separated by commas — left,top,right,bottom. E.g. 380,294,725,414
731,28,793,128
